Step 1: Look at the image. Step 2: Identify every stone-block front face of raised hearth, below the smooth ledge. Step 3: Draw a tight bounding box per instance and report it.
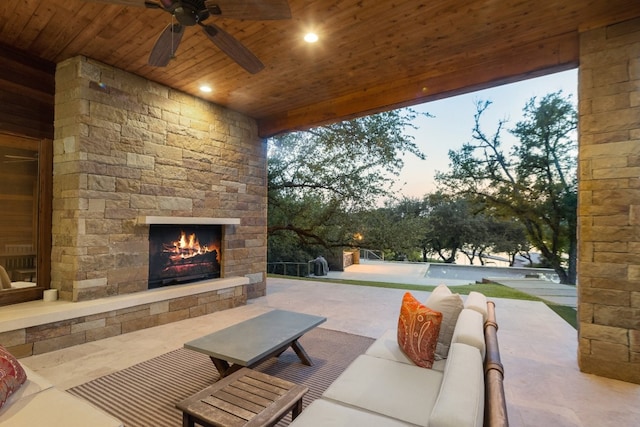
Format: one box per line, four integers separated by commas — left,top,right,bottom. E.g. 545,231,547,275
0,285,247,357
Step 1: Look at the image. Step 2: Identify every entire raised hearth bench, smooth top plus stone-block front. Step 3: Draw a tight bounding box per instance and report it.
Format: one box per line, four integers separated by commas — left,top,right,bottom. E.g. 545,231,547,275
0,278,248,357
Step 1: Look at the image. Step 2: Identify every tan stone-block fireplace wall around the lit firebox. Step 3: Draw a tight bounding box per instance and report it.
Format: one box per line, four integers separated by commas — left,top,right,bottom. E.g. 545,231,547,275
51,57,267,301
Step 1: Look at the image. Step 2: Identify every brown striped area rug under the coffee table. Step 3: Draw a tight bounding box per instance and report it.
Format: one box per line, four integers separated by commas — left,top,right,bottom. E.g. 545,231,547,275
68,328,373,427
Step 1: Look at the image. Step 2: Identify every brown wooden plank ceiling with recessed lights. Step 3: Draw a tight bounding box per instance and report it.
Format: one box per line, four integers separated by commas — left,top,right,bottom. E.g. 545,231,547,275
0,0,640,136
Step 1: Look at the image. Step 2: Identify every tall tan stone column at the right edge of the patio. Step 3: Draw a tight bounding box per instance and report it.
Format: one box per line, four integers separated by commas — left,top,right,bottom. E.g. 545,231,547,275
578,19,640,383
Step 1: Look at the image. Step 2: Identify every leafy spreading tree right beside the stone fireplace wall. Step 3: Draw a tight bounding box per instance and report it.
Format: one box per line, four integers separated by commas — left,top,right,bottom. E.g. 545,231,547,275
267,109,424,261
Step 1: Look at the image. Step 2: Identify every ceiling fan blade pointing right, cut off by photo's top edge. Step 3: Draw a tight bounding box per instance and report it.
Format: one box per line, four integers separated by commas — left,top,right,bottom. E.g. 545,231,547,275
204,0,291,21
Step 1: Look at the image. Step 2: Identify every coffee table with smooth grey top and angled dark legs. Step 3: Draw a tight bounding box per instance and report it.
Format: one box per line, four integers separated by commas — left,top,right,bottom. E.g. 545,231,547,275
184,310,327,377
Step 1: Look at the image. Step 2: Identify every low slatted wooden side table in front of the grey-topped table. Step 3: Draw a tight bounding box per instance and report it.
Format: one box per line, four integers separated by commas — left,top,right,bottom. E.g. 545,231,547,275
176,368,309,427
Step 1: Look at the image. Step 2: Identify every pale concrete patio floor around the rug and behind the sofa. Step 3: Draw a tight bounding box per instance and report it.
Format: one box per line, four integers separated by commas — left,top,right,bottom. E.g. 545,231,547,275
21,278,640,427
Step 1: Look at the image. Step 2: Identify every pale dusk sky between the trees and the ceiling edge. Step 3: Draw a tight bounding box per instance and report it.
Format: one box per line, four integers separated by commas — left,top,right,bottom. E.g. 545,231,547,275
395,69,578,198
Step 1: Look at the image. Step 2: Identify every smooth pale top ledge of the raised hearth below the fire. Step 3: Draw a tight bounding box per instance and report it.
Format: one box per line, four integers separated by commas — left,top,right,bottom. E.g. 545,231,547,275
0,277,249,333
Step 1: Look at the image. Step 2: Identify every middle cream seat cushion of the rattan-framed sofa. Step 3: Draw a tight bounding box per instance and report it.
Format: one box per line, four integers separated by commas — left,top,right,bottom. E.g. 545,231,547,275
322,355,443,426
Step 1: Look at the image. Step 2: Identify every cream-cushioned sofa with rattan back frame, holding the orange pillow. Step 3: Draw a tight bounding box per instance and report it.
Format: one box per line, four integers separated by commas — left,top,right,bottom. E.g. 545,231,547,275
290,293,508,427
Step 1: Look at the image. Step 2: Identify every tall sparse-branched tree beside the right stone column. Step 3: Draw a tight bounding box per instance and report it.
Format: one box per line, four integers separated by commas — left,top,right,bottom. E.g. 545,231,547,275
436,92,577,283
